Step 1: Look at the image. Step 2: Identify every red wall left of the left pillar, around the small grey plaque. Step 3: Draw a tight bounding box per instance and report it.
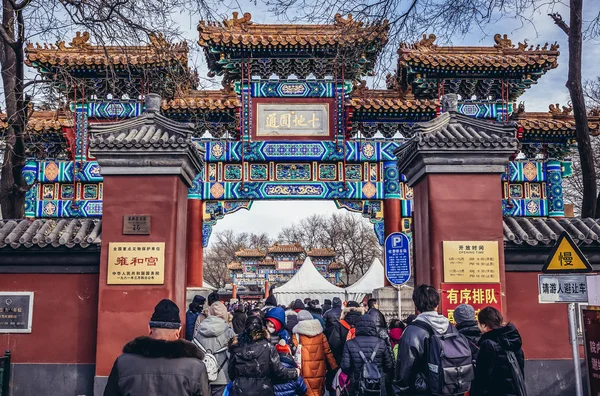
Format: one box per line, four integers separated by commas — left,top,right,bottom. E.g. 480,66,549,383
0,274,98,363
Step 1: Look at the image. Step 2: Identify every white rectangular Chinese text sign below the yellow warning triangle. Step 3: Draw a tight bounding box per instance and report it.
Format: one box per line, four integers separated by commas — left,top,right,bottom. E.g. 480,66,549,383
538,274,588,303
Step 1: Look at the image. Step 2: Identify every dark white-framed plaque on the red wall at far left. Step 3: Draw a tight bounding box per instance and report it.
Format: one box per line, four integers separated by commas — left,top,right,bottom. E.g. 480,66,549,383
0,292,33,333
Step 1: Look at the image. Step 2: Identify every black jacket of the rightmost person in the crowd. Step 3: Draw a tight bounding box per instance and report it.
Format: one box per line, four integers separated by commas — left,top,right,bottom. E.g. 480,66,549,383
471,324,525,396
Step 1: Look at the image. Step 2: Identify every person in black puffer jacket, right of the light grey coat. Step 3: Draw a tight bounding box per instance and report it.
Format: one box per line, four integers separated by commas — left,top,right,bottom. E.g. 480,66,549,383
228,316,298,396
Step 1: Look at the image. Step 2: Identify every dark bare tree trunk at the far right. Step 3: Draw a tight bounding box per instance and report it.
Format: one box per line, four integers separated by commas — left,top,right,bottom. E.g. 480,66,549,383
566,0,597,217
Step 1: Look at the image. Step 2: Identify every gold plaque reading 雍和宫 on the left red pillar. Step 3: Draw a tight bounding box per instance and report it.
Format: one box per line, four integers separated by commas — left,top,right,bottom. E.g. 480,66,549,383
107,242,165,285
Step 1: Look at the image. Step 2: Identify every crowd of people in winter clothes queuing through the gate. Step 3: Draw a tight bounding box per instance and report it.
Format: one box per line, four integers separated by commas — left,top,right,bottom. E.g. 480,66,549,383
104,285,526,396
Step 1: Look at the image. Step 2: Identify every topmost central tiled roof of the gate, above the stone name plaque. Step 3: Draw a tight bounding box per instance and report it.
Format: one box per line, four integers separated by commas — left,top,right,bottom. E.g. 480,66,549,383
198,12,389,49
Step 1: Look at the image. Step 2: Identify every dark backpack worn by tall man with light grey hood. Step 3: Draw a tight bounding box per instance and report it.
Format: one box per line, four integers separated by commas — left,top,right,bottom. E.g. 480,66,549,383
411,320,475,395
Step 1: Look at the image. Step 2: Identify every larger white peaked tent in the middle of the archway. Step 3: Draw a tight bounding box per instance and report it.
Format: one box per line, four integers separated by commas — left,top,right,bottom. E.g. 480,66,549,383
273,257,344,305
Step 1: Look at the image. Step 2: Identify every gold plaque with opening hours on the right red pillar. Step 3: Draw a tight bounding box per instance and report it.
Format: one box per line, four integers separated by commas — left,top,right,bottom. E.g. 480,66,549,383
443,241,500,283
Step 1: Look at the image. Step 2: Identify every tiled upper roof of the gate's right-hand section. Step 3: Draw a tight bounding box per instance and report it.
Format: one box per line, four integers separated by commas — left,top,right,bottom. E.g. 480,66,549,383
398,34,560,73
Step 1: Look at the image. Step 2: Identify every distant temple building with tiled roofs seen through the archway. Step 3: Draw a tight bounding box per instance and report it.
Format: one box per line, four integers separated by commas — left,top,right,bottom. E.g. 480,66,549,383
227,242,343,290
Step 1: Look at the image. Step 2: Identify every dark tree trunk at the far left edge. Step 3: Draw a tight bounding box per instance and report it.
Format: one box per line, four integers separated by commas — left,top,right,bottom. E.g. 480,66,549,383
0,0,28,219
